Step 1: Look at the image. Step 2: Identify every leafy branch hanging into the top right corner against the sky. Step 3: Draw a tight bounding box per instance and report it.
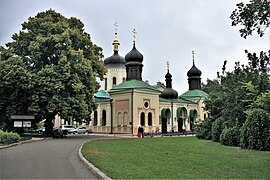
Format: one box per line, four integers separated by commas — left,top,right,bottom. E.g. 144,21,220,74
230,0,270,38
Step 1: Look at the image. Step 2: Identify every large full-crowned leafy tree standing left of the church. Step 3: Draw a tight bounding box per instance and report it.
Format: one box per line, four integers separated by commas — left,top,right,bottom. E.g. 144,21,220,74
1,9,105,133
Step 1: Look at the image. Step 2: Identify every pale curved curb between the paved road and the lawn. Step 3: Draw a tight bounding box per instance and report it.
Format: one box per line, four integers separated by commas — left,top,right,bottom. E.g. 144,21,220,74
78,141,111,180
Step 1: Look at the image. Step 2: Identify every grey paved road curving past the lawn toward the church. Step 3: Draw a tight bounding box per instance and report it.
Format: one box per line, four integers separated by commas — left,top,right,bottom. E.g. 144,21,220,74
0,135,112,179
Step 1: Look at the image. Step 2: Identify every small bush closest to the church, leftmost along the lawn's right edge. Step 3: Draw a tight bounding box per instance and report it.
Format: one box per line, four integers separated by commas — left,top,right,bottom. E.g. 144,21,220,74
195,118,212,140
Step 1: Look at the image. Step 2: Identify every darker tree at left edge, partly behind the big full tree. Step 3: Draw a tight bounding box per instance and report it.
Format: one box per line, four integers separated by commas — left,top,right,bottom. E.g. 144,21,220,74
0,47,32,130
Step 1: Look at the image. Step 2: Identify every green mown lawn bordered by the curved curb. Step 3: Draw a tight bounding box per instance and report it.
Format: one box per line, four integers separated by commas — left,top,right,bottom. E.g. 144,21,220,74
82,137,270,179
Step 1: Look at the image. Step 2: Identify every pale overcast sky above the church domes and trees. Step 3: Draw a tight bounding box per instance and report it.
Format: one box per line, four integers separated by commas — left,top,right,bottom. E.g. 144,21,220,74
0,0,270,95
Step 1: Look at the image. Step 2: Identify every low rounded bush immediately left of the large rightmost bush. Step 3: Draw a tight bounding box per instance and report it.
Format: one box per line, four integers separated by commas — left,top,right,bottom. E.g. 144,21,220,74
220,126,240,146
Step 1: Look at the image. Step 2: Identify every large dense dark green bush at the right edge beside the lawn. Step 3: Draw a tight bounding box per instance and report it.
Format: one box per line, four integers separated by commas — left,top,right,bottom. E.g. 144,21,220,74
240,109,270,151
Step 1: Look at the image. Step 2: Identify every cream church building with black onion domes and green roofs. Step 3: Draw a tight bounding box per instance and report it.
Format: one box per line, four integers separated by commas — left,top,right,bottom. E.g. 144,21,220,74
90,29,208,134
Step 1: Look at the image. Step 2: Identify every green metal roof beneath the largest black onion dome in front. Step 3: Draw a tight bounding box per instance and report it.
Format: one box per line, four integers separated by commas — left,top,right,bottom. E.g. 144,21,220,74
109,79,160,93
